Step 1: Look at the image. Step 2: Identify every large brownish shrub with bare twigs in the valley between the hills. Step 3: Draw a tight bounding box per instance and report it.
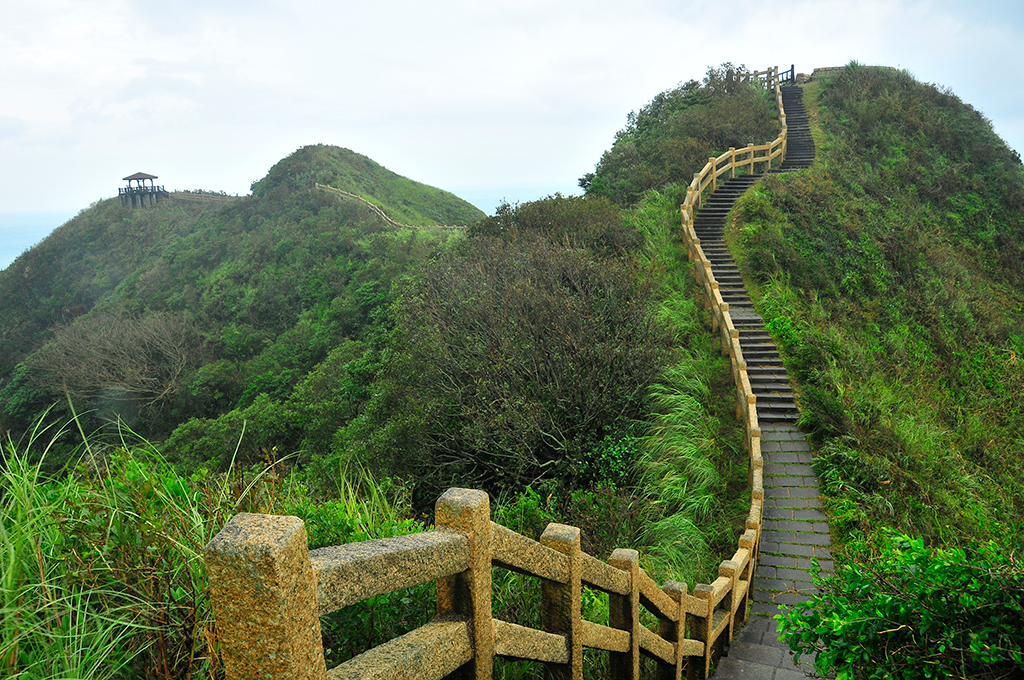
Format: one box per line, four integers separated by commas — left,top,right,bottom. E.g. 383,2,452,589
337,237,670,498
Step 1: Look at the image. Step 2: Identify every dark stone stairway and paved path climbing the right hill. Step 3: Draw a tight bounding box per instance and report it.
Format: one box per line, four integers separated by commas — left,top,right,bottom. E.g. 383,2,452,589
693,85,833,680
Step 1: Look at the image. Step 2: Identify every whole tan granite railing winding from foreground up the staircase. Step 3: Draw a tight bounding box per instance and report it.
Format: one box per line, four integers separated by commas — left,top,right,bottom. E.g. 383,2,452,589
205,63,827,680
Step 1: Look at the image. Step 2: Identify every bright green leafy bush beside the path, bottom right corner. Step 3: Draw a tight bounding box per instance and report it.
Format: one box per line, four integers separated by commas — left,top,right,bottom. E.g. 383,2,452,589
778,533,1024,680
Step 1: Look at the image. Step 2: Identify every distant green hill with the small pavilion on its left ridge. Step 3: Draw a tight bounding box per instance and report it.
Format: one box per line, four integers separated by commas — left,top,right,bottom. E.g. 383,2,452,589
0,145,483,462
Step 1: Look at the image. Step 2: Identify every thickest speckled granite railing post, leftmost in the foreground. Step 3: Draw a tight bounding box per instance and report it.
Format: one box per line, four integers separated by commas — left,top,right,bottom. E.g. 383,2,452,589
204,513,327,680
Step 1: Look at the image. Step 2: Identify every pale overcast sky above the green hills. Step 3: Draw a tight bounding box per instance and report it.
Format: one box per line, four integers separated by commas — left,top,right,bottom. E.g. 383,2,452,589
0,0,1024,266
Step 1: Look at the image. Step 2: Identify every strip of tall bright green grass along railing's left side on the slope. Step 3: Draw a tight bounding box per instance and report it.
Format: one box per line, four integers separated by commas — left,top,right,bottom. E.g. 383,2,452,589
631,187,750,584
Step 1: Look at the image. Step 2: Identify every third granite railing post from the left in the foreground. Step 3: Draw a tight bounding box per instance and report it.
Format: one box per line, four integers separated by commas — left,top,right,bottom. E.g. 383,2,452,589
541,522,583,680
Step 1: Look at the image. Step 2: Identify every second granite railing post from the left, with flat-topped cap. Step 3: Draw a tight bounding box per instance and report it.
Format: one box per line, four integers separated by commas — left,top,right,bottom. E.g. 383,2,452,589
434,488,495,680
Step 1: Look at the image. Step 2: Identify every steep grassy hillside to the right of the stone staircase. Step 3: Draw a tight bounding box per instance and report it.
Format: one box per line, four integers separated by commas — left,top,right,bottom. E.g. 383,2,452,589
730,63,1024,542
